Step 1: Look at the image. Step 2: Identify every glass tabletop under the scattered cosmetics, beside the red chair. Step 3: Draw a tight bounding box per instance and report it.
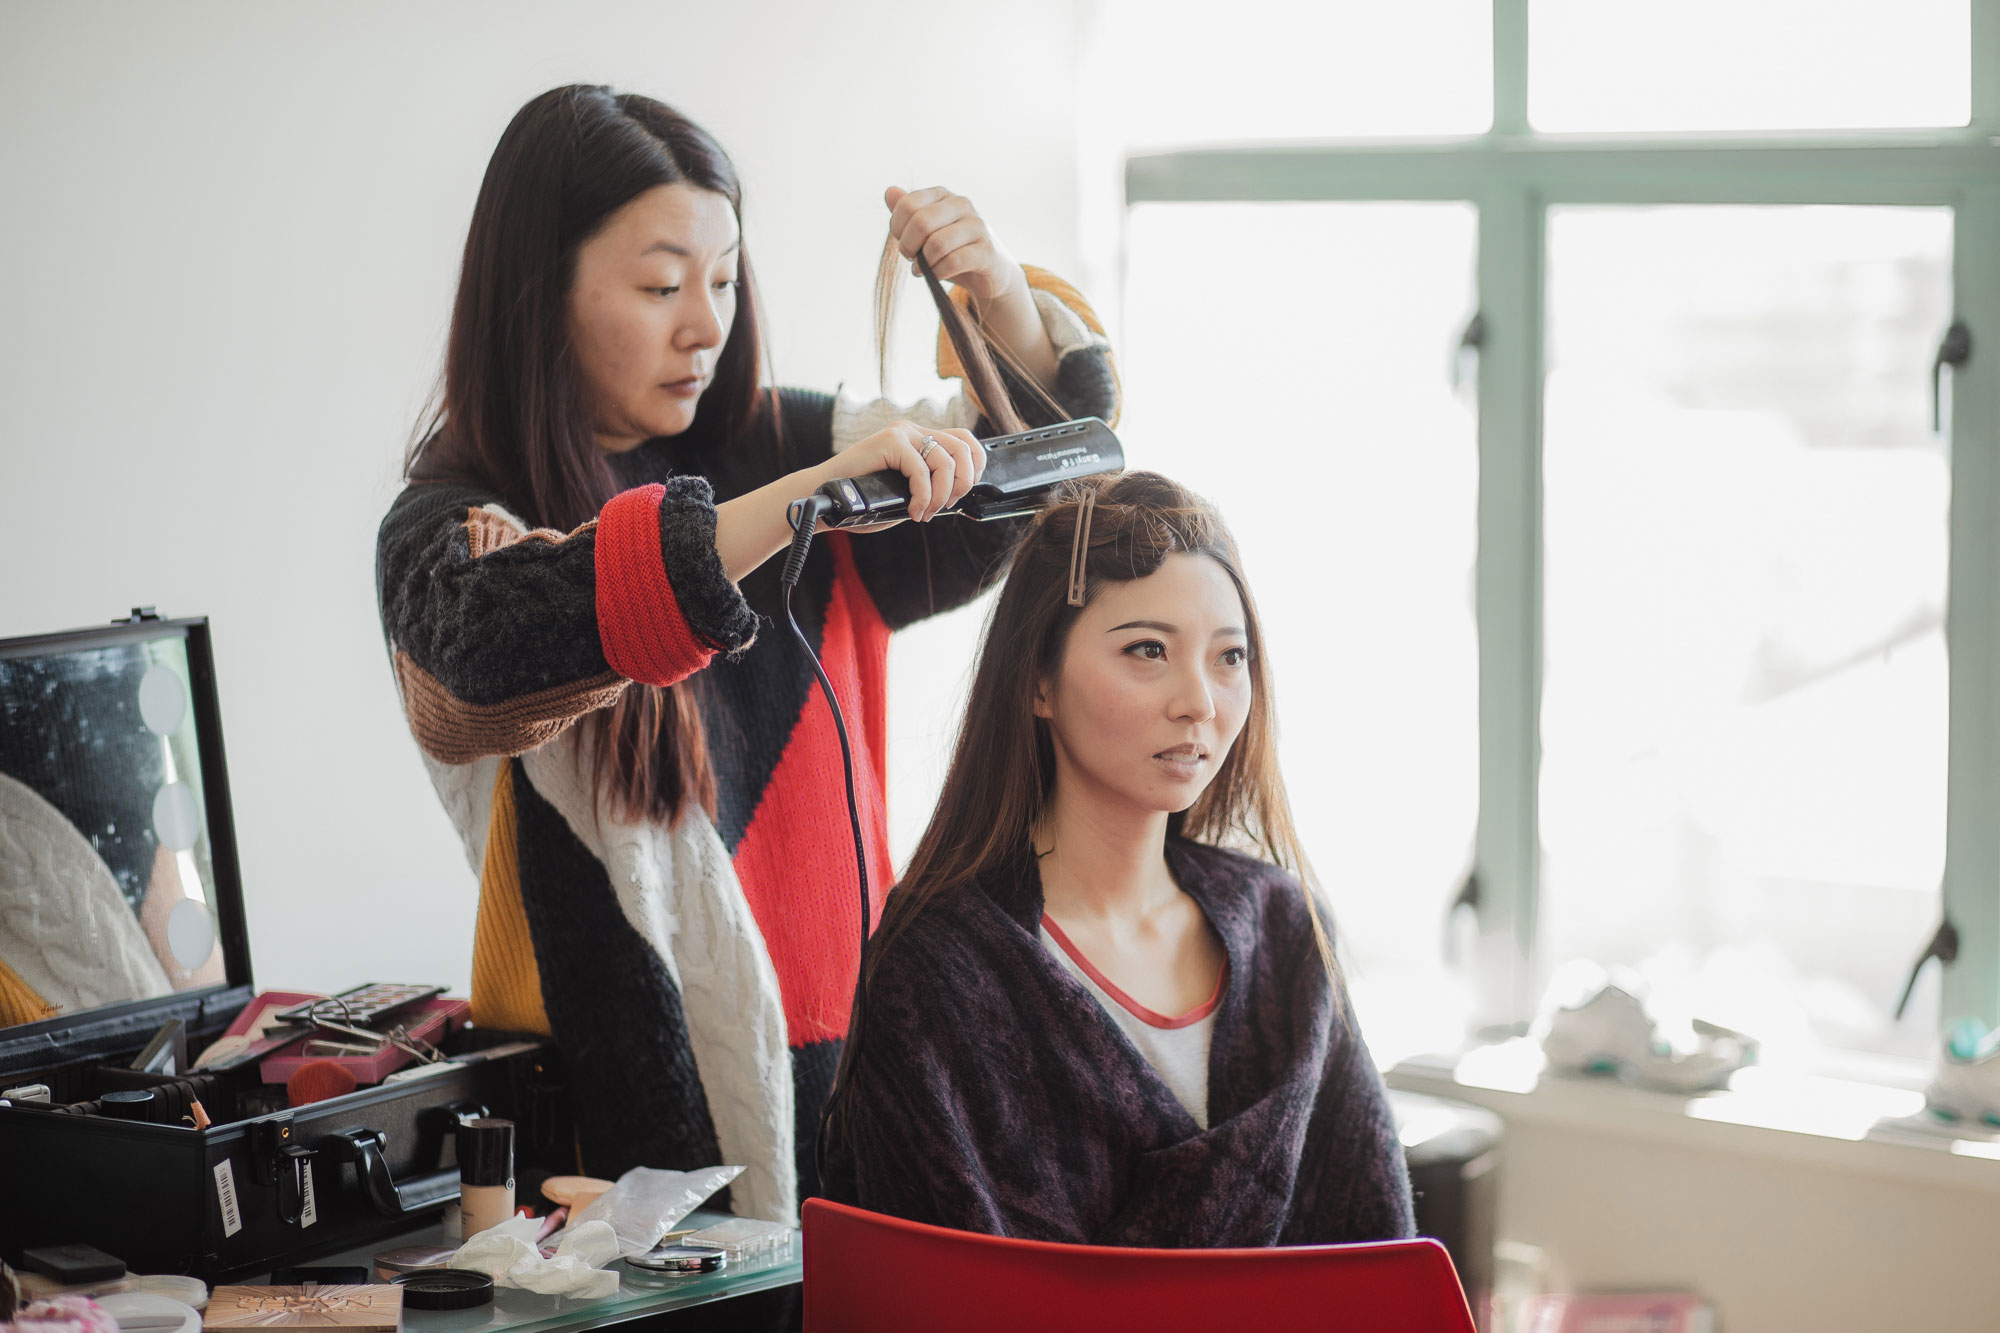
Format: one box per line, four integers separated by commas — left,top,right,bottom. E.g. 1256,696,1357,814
302,1209,804,1333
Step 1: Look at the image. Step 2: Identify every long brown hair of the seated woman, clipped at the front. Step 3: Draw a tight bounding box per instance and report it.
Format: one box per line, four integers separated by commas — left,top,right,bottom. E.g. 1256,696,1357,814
830,472,1340,1131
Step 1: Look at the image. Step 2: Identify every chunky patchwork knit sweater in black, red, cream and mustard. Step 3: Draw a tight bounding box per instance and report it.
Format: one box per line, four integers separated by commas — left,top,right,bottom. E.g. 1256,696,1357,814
376,270,1118,1219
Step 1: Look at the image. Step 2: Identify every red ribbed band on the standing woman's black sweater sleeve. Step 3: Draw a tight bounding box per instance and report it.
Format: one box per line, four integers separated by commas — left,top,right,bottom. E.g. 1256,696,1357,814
596,484,716,685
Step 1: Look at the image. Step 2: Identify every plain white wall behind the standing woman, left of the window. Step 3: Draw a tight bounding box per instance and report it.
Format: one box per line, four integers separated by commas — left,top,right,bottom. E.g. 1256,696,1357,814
0,0,1076,989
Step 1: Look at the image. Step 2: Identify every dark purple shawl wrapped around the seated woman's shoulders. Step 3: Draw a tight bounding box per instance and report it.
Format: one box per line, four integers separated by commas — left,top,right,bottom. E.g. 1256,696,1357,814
822,839,1412,1247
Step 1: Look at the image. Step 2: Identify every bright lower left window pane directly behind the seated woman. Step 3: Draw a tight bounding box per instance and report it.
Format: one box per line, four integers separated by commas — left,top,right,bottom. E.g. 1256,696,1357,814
1118,204,1478,1059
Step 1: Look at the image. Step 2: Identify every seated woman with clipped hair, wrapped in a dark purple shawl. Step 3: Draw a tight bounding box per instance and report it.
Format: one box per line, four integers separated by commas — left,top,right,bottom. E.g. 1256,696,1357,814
822,472,1412,1247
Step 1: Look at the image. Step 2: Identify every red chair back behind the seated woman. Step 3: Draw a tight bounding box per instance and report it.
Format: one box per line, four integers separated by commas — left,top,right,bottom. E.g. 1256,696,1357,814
804,1199,1472,1333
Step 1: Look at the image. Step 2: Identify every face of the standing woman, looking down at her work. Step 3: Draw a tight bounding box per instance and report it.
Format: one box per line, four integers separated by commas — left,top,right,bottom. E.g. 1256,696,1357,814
570,184,742,452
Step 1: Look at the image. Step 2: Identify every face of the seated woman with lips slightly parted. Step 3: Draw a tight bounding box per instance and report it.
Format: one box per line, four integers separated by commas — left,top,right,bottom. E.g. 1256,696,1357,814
1034,554,1250,813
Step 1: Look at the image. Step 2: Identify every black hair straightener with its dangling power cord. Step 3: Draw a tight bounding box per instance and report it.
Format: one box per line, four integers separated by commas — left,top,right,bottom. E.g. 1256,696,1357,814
780,416,1124,1184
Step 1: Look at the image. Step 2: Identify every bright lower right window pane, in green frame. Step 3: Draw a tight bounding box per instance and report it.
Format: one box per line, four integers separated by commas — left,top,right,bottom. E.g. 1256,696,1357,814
1540,206,1952,1063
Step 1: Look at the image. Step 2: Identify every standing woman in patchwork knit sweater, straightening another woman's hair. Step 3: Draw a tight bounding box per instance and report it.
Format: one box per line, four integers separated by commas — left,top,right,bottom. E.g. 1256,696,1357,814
376,86,1118,1219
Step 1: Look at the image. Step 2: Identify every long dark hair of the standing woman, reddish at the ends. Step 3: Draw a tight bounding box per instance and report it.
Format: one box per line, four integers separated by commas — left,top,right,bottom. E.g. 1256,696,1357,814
404,84,778,823
